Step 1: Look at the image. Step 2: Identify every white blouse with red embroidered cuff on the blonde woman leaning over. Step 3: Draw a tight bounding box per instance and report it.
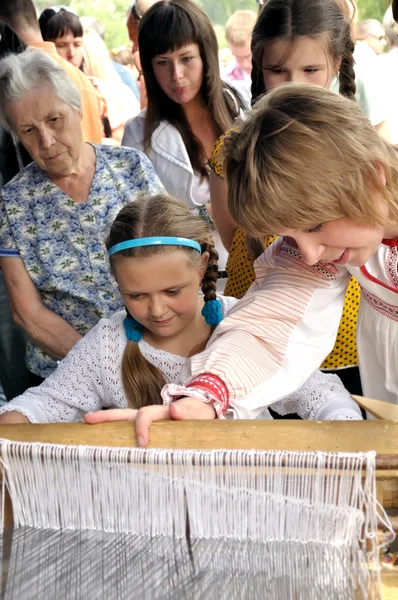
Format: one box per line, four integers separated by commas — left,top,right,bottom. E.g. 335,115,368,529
176,238,398,411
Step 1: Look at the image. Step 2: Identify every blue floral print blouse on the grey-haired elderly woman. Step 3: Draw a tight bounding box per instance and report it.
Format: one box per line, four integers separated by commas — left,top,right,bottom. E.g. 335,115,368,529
0,144,164,377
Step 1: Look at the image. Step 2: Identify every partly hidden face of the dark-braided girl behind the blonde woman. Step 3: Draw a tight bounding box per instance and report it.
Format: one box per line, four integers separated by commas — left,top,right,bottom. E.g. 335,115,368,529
262,37,340,91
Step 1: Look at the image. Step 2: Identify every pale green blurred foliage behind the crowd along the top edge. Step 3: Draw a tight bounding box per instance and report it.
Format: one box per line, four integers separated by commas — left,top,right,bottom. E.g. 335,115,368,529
33,0,389,48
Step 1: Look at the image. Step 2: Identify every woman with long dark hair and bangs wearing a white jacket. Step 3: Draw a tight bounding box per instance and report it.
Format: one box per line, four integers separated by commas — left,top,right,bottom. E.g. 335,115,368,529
122,0,246,290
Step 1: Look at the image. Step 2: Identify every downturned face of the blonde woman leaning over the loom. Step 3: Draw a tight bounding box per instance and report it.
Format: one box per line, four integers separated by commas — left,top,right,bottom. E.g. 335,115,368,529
278,219,385,267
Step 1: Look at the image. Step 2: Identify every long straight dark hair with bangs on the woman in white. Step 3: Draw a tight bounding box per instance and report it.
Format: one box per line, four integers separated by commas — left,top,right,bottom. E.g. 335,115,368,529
138,0,241,177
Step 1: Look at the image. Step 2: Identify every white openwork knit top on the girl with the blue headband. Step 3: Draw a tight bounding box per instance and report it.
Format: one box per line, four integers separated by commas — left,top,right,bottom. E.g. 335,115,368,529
0,297,362,423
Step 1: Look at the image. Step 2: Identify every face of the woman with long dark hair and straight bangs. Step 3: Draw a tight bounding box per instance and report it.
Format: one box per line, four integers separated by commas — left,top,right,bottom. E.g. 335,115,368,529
152,44,203,105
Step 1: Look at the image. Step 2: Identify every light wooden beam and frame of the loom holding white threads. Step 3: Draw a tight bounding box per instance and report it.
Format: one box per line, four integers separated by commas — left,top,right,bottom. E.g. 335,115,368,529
0,398,398,600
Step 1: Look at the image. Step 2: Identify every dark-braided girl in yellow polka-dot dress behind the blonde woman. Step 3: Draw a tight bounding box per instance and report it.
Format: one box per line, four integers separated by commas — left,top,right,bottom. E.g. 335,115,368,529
210,0,361,394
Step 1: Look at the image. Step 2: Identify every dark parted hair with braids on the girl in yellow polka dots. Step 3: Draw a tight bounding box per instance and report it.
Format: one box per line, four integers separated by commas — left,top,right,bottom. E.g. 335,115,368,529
251,0,356,103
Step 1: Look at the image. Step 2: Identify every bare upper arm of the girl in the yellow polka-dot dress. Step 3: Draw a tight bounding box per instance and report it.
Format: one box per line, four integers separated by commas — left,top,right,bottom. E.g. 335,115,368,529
209,171,237,251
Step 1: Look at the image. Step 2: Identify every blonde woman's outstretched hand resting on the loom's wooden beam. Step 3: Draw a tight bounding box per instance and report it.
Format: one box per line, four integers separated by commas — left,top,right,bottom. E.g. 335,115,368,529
84,398,216,448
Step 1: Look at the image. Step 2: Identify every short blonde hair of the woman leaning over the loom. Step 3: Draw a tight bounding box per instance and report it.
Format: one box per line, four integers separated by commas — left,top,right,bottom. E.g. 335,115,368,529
224,84,398,236
